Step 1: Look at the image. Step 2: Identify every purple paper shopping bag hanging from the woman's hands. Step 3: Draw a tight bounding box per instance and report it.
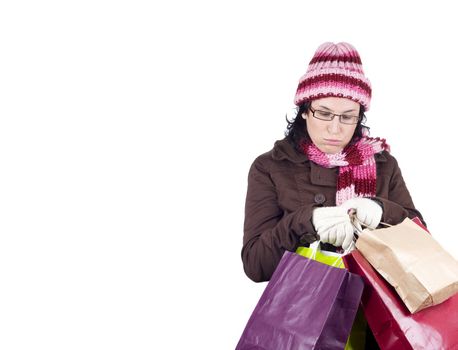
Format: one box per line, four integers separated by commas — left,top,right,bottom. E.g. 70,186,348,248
236,251,364,350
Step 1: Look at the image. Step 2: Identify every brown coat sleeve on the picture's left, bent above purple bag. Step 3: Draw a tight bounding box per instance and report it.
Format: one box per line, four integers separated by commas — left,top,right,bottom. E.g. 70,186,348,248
242,158,316,282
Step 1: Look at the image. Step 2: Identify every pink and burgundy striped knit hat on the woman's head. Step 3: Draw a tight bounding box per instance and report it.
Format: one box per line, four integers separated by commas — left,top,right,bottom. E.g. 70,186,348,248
294,42,372,111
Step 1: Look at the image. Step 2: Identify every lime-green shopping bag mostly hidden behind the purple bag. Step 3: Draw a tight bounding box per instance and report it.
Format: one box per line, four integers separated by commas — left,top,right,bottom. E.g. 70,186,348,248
296,242,367,350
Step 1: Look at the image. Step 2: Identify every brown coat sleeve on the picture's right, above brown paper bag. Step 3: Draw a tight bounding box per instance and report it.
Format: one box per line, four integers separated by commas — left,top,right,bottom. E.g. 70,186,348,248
375,157,426,226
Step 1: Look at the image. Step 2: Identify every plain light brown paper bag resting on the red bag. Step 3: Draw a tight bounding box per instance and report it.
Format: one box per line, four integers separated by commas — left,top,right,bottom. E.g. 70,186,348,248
356,218,458,313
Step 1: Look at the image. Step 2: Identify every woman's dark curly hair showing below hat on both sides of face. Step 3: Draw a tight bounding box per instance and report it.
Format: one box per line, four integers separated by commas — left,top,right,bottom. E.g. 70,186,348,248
285,102,370,149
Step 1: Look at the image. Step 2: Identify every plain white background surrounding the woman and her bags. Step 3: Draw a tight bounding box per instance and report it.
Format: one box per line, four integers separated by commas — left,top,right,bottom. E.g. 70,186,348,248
0,0,458,350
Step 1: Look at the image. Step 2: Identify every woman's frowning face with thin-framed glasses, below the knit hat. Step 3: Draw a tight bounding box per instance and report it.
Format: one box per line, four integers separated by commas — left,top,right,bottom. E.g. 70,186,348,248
302,97,360,154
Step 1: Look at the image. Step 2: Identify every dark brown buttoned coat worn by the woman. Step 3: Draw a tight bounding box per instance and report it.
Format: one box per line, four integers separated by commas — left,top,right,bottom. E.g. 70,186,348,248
242,139,423,282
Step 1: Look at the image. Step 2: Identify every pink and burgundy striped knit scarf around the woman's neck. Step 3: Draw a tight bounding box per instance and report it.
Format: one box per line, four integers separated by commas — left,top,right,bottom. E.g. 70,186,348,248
301,136,390,205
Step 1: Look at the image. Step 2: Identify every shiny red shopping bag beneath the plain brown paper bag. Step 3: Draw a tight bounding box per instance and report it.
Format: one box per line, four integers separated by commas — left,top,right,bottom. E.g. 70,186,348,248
342,250,458,350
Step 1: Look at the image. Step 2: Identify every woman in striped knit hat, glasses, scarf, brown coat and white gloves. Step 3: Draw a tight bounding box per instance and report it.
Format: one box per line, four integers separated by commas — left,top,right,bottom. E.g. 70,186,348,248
242,43,422,282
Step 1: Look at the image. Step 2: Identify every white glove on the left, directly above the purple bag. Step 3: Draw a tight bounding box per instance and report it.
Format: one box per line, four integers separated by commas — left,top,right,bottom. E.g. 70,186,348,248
312,207,353,249
